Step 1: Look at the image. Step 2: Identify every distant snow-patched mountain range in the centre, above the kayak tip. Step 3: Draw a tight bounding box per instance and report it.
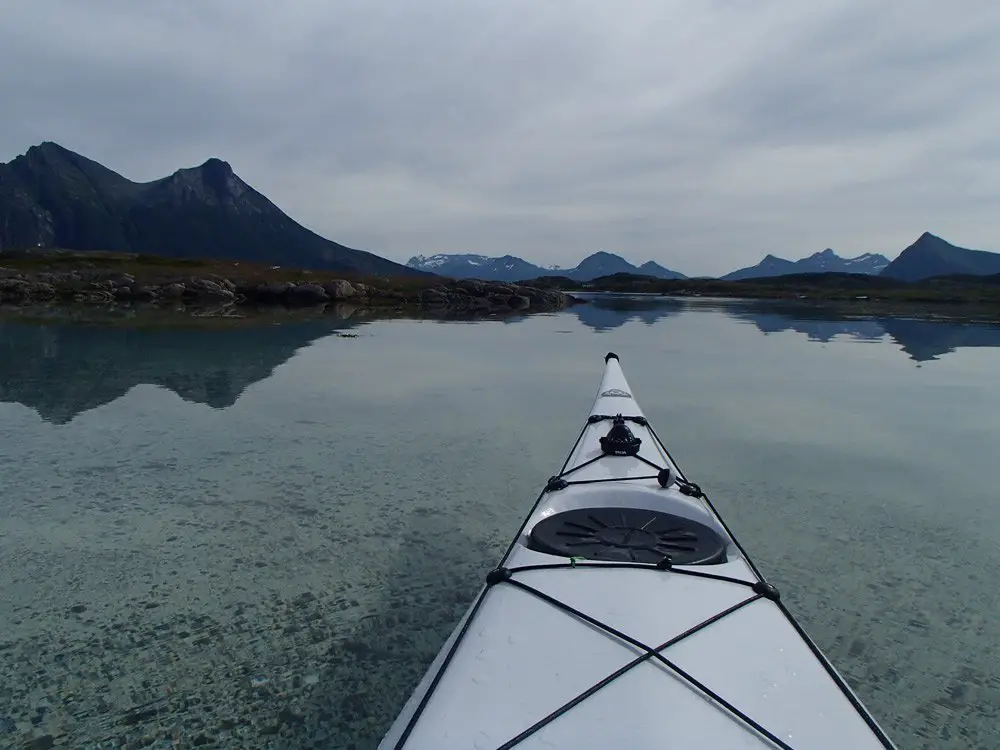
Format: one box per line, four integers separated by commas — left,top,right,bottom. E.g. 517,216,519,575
406,251,687,281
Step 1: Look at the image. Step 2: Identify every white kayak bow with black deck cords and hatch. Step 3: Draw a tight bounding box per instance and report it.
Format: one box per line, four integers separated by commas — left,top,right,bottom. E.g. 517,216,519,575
379,353,895,750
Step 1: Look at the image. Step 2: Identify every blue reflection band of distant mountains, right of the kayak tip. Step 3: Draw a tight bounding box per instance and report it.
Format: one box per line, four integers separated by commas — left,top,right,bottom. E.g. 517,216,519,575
572,295,1000,362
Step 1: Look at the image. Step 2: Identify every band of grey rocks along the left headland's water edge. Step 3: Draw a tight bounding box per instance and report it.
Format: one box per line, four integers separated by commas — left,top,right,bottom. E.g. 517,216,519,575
0,267,576,314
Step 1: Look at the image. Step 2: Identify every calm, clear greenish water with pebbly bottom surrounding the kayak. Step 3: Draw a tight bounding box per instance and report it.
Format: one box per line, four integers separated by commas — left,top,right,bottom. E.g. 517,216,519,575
0,299,1000,749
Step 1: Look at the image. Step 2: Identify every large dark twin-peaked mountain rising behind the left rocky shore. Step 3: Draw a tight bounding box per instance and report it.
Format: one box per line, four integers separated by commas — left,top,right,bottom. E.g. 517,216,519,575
0,142,421,276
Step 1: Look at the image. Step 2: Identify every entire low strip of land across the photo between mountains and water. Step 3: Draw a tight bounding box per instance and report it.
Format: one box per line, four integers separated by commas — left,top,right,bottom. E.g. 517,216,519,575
0,250,1000,321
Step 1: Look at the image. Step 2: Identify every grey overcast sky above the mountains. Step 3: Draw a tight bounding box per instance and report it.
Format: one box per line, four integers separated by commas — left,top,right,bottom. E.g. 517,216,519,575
0,0,1000,274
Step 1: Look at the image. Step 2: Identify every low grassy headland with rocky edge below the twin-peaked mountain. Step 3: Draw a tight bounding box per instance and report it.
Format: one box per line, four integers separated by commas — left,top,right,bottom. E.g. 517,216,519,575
0,250,574,315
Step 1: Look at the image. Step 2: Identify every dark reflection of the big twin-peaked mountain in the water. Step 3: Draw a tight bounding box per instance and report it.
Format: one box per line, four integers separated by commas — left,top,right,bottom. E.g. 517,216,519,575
0,315,357,424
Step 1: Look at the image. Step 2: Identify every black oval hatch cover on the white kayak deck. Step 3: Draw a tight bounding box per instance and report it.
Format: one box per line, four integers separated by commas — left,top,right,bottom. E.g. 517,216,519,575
531,508,726,565
